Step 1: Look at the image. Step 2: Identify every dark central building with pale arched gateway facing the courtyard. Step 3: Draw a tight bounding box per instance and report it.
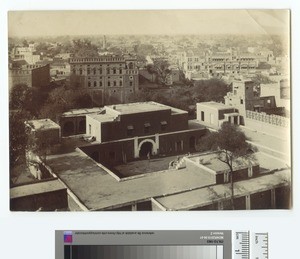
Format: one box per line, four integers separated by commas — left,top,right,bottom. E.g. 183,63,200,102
81,102,206,164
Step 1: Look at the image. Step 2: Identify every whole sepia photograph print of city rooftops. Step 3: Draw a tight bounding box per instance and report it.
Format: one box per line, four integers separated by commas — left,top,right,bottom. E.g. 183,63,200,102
8,9,292,212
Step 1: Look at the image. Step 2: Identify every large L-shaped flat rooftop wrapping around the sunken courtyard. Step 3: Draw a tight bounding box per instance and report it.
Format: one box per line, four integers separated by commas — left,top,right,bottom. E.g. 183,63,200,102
47,151,215,210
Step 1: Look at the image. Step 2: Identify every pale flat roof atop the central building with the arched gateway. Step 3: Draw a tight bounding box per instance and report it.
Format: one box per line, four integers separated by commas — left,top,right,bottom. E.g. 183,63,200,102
106,102,187,114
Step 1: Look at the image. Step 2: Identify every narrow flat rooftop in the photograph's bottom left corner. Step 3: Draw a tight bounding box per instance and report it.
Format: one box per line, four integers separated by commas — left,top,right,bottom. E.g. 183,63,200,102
10,179,66,199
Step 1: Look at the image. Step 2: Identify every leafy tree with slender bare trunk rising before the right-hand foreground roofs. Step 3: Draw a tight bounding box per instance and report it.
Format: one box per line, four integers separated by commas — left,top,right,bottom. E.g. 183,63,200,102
201,122,252,209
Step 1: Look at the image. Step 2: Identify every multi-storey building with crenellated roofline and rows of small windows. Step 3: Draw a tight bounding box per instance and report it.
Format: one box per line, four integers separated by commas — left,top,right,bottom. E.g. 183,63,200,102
70,55,139,105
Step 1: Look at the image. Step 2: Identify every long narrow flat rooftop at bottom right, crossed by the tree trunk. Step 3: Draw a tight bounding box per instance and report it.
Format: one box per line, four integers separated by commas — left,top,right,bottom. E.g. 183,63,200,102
155,169,291,210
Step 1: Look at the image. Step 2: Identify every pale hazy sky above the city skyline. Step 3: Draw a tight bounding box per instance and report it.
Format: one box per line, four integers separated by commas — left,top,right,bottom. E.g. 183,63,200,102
8,10,289,37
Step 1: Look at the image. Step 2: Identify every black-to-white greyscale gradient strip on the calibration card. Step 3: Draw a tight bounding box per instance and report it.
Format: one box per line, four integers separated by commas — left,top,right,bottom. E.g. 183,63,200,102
64,245,224,259
